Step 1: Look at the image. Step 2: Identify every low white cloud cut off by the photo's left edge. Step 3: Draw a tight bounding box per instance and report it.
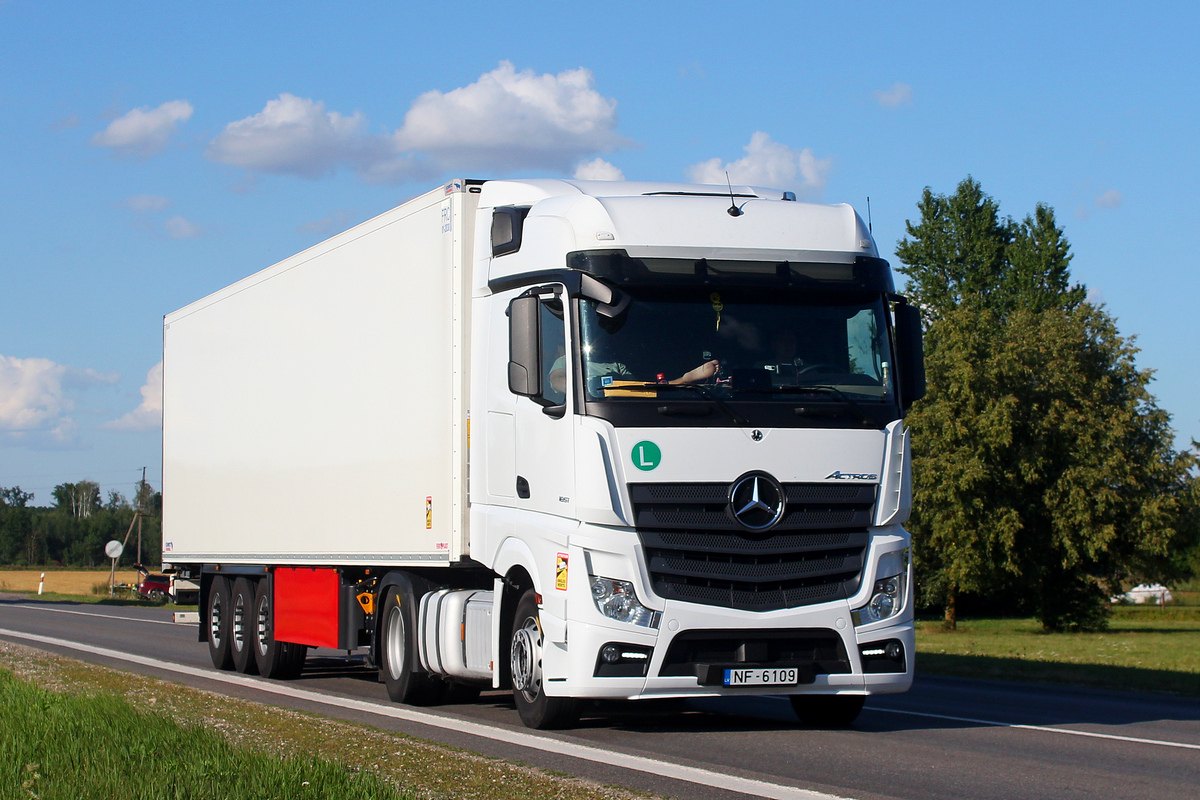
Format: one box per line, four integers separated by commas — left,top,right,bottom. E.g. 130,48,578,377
0,355,118,444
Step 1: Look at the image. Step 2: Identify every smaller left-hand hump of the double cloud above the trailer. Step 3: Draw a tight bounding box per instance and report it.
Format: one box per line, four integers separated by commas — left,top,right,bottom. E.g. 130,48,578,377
204,94,384,179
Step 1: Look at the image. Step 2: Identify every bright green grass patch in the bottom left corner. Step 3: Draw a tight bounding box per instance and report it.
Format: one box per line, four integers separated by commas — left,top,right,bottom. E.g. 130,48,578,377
0,672,413,800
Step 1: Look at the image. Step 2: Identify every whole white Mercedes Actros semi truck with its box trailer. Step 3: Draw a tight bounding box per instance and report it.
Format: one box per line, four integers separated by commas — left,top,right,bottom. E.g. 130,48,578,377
163,180,924,728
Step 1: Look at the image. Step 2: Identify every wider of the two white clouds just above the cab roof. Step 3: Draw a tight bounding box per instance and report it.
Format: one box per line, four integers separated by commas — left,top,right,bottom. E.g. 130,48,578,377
686,131,833,197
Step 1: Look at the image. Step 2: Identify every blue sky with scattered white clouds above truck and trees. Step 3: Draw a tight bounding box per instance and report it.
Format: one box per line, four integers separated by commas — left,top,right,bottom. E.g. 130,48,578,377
0,0,1200,505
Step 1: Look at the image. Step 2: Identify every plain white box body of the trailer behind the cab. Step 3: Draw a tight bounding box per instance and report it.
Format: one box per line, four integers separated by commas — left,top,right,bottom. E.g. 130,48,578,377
163,184,476,566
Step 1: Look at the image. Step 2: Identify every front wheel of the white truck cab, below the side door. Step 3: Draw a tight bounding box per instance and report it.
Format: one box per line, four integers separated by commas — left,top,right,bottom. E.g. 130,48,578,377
509,589,580,730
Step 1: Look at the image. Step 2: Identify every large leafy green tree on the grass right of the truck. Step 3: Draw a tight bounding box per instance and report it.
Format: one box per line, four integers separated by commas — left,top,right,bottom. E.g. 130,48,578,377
896,178,1194,630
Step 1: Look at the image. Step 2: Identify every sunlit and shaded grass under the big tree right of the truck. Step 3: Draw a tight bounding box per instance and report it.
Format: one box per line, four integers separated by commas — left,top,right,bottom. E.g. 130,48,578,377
917,606,1200,697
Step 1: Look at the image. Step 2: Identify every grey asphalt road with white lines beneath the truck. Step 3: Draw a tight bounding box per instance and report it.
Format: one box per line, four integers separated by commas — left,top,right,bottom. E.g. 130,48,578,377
0,595,1200,800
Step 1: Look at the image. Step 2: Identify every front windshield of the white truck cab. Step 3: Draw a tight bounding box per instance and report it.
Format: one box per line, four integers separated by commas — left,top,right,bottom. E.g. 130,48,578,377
580,285,895,407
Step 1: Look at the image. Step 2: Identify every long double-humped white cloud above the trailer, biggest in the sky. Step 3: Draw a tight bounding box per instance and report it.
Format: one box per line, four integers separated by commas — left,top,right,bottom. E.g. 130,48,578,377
205,61,632,182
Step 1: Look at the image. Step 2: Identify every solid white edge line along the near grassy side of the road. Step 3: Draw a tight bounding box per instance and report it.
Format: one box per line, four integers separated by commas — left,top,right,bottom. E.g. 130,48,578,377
0,628,847,800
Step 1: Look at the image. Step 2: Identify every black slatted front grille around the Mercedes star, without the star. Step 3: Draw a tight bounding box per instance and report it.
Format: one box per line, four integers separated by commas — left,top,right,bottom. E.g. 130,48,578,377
629,483,876,612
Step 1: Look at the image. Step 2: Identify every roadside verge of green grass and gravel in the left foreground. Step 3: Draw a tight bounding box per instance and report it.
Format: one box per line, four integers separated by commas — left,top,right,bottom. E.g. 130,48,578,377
0,642,648,800
